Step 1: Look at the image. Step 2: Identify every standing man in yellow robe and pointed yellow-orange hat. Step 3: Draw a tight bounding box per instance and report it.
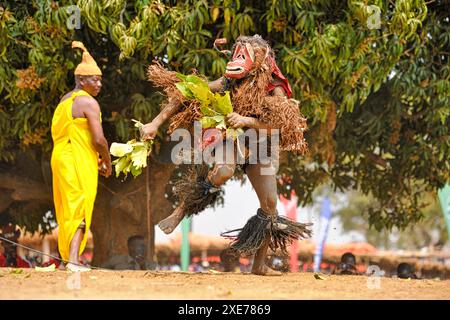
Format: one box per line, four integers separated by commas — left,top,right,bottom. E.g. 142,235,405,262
51,41,111,271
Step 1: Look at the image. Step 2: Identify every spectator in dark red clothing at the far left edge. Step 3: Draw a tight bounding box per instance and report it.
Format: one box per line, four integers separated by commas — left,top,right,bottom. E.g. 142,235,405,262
0,223,31,268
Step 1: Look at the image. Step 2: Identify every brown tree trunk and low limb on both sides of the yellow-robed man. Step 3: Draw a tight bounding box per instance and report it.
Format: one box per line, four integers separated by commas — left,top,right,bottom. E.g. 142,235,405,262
0,155,175,266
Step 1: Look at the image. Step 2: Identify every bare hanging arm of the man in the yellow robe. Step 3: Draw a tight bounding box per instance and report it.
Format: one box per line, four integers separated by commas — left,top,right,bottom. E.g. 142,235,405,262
80,97,111,176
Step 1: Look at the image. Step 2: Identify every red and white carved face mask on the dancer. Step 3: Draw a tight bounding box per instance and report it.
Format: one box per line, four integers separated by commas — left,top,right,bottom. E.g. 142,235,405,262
225,43,255,79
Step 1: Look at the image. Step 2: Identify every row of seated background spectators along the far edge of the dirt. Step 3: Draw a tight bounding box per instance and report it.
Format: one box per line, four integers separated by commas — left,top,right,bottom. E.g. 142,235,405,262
0,223,442,279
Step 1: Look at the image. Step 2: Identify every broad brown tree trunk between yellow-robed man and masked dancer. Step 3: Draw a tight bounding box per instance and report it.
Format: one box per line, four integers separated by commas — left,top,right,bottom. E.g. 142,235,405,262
91,162,174,266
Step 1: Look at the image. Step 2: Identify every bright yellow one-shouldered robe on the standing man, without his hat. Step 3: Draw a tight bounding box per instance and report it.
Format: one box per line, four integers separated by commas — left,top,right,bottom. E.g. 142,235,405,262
51,90,101,261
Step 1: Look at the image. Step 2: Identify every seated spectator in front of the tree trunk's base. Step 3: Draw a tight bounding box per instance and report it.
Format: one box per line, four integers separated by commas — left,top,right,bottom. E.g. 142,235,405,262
102,236,155,270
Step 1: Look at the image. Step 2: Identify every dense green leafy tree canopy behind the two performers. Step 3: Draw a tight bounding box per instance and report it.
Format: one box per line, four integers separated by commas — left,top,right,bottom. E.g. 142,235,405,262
0,0,450,234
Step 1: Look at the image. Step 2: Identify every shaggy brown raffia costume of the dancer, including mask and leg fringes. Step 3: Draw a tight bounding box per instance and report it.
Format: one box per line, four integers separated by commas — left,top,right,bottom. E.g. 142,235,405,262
148,35,310,275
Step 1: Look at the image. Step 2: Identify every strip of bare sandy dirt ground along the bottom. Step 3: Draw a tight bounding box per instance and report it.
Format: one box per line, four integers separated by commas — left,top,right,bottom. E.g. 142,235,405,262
0,268,450,300
